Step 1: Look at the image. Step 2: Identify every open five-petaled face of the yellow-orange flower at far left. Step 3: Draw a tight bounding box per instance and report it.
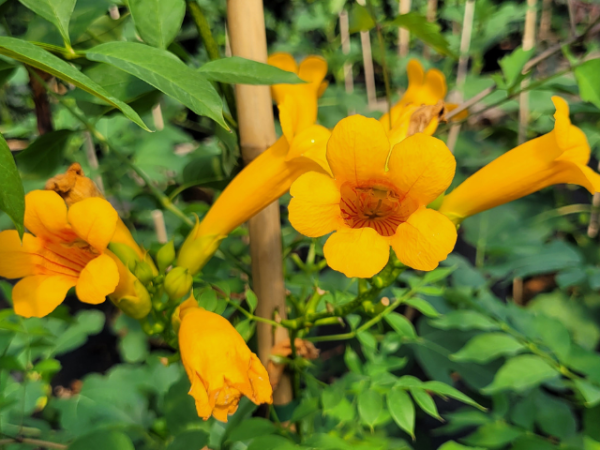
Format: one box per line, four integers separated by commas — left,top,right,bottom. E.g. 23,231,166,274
0,191,119,317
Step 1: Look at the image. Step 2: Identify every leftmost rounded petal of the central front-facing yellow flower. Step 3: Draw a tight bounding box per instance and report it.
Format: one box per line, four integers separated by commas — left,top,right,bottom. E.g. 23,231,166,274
288,172,343,237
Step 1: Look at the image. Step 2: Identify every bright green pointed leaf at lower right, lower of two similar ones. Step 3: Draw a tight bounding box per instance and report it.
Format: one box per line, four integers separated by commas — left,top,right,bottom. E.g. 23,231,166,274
483,355,558,394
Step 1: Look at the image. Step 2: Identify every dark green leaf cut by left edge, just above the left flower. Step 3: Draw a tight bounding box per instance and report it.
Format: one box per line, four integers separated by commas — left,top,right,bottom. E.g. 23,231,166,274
0,134,25,237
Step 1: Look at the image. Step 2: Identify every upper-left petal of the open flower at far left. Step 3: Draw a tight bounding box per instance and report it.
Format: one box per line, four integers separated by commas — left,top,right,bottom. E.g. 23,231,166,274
25,191,77,242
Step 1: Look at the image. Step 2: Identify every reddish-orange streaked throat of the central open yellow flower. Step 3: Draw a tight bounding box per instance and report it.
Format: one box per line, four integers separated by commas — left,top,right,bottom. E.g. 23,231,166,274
340,183,414,236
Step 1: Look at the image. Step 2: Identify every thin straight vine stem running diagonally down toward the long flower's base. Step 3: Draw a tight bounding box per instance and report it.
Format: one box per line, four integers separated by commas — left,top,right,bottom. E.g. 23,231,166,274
31,72,194,227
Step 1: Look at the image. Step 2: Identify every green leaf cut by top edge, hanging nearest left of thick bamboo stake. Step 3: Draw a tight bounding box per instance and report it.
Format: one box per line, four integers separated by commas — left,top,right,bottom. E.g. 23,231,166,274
129,0,185,48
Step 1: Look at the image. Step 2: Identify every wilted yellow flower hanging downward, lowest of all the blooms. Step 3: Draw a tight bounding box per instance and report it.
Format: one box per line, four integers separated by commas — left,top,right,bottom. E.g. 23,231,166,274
179,296,273,422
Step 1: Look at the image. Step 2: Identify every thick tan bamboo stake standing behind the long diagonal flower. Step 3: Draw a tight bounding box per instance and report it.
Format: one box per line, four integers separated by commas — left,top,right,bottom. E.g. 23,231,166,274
227,0,293,405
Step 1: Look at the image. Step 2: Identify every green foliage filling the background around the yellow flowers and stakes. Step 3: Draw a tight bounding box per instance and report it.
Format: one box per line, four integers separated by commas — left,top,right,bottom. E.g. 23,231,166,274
0,0,600,450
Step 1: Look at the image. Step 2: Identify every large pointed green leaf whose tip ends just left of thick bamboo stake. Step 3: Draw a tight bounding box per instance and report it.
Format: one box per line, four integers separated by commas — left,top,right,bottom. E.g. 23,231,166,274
86,42,229,129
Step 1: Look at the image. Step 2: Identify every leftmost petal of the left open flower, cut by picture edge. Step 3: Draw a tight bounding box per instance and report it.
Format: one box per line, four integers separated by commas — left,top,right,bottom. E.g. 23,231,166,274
0,230,41,278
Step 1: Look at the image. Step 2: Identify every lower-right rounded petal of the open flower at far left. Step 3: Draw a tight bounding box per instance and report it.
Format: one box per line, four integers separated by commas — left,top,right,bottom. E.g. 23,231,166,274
75,255,119,305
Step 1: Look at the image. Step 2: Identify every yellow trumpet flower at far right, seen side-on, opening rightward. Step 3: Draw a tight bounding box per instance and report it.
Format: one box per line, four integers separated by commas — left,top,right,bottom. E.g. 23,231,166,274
439,97,600,224
